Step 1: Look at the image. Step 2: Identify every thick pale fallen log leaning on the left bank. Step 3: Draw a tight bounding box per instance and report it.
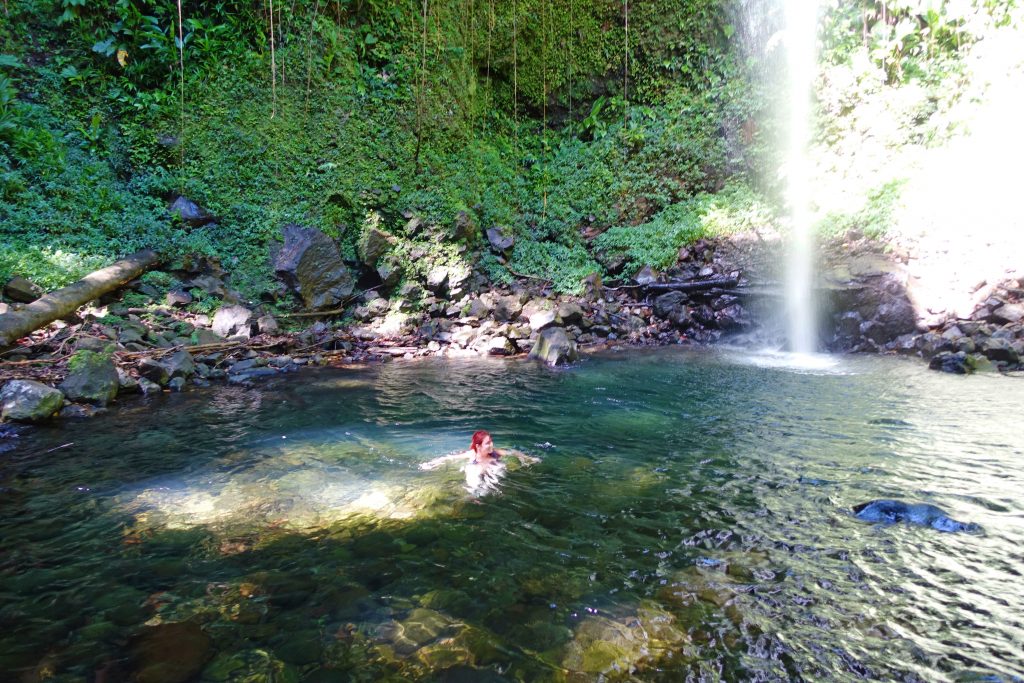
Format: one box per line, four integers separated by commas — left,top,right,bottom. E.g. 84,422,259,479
0,250,160,348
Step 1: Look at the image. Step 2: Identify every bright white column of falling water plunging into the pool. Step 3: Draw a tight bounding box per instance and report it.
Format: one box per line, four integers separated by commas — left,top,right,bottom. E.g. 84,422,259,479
784,0,817,353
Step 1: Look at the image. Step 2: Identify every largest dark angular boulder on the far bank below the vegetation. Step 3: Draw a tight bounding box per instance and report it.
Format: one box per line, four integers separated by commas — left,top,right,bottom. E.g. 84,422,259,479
273,223,355,308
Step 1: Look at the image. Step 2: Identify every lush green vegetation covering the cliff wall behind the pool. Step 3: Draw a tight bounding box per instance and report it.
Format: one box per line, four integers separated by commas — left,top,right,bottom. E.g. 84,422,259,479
0,0,1019,296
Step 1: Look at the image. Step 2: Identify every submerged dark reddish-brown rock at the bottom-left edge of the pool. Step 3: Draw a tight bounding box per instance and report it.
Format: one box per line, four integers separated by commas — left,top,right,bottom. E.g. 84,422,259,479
129,622,212,683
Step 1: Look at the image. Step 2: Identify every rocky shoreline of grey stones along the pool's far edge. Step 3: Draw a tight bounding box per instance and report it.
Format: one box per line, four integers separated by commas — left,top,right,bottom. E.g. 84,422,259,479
0,227,1024,432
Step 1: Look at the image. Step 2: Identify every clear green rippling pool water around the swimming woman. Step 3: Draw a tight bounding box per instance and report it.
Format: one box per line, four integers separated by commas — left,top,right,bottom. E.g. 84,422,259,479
0,349,1024,683
